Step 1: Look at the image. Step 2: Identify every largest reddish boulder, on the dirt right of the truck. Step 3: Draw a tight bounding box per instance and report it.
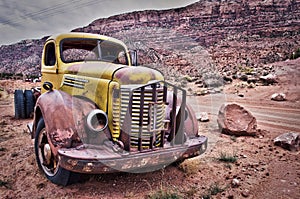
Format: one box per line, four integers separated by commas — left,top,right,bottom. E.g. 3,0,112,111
217,103,257,136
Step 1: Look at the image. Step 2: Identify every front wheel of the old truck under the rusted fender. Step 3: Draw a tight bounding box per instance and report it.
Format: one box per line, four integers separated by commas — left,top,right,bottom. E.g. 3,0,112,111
34,118,79,186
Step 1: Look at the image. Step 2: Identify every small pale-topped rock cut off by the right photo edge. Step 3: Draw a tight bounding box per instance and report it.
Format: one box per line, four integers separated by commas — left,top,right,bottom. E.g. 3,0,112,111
274,132,300,151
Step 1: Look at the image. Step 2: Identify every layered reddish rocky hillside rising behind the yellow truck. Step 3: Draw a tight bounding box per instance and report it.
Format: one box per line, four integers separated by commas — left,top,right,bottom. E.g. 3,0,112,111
0,0,300,80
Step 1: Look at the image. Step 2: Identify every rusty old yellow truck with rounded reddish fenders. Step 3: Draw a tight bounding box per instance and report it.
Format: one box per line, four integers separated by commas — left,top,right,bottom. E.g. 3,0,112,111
15,33,207,185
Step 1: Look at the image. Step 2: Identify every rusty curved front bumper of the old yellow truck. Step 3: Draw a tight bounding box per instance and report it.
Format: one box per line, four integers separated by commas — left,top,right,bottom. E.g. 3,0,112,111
58,136,207,174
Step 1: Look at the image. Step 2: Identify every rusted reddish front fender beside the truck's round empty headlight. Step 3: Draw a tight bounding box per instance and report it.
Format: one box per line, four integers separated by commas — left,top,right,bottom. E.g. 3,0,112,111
32,90,95,155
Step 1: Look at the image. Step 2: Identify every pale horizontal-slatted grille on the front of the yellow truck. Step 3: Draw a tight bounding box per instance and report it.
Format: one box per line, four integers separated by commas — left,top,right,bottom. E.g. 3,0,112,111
120,84,165,150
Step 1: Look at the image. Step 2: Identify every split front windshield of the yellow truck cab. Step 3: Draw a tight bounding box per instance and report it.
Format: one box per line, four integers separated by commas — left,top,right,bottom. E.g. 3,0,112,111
60,38,128,65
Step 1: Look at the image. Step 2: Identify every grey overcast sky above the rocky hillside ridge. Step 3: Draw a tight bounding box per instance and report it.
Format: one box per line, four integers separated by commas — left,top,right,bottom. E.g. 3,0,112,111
0,0,198,45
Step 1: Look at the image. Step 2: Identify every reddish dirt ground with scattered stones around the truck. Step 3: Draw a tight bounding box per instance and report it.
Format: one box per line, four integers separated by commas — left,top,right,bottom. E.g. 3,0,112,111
0,60,300,199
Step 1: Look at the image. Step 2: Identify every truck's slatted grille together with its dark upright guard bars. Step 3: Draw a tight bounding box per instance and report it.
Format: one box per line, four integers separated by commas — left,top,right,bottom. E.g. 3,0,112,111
113,81,186,151
